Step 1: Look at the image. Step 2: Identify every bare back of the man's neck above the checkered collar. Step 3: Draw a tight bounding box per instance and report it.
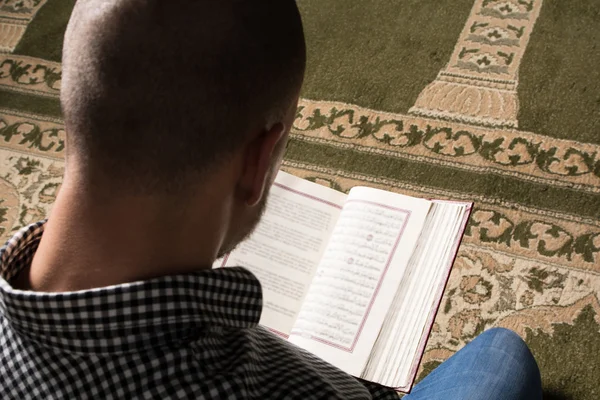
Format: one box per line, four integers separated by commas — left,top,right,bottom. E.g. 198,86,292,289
15,173,228,292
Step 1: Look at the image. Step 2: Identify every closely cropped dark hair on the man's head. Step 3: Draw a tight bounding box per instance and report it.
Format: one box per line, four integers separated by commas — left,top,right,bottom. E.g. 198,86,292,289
61,0,306,193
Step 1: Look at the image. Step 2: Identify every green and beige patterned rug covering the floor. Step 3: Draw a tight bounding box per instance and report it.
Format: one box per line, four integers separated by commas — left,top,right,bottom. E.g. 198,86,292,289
0,0,600,399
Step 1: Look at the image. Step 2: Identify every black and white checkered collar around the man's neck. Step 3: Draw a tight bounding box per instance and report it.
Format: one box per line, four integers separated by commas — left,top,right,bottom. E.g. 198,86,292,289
0,221,262,353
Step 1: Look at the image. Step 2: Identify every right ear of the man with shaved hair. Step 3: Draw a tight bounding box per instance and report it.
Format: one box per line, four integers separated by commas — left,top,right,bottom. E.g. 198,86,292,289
239,123,285,207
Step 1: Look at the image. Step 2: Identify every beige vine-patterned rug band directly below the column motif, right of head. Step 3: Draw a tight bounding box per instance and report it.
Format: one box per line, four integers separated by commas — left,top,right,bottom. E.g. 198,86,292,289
294,99,600,193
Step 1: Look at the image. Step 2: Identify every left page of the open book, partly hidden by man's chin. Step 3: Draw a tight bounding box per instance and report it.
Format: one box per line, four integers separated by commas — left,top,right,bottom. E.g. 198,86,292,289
215,172,346,337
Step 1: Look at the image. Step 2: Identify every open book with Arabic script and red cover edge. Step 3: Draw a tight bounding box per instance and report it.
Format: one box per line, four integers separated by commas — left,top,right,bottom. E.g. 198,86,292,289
215,172,472,392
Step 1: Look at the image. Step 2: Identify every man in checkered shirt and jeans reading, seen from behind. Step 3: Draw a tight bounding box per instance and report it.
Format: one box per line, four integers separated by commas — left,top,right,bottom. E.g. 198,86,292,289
0,0,540,399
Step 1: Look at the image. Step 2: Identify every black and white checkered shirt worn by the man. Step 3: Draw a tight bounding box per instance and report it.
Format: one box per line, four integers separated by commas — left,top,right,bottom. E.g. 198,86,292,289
0,221,398,400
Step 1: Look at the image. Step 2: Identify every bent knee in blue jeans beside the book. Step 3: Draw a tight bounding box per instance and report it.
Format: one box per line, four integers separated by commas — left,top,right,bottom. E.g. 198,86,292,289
403,328,542,400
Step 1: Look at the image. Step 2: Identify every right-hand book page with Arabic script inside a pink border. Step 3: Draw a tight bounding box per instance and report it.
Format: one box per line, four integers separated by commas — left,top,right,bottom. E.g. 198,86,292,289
289,187,431,376
